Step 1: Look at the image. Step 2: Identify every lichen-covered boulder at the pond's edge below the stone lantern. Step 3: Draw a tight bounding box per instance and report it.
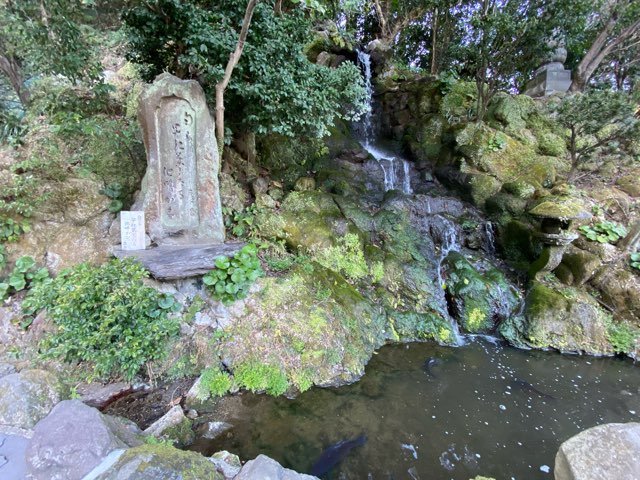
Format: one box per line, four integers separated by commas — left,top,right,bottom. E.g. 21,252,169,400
524,281,614,355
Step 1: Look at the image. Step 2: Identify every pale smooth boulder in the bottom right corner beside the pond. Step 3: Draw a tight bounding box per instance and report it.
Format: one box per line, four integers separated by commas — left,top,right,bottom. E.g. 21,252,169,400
554,423,640,480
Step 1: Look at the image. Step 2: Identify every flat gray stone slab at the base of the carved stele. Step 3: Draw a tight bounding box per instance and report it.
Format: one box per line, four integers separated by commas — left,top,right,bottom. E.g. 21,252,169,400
113,243,245,280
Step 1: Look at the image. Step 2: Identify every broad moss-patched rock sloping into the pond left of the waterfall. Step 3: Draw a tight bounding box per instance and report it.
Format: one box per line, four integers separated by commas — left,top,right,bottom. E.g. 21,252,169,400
221,263,391,395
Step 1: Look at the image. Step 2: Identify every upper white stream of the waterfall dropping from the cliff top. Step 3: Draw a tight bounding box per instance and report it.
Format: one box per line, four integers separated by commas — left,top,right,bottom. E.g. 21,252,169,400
358,51,413,195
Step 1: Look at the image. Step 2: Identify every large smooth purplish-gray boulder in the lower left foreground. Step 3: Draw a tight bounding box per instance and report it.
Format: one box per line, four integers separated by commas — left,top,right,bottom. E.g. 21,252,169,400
26,400,142,480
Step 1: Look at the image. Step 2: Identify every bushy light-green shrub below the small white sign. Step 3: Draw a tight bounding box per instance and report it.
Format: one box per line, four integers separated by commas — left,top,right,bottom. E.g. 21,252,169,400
23,260,180,380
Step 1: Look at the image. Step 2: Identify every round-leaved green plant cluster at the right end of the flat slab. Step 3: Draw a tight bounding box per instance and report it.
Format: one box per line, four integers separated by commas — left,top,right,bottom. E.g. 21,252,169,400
202,244,264,305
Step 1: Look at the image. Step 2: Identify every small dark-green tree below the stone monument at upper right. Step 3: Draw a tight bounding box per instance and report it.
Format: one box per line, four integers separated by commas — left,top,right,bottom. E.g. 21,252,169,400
552,90,640,170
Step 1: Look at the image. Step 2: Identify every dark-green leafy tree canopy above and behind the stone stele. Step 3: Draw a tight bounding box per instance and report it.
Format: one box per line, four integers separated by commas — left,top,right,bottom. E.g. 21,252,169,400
123,0,366,137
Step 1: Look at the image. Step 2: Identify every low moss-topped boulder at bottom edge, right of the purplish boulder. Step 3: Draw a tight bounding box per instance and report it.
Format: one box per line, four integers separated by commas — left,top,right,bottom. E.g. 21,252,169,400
96,445,224,480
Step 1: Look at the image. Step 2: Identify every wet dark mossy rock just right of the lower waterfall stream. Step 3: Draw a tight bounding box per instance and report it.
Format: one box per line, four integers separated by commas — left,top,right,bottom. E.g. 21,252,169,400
443,252,519,333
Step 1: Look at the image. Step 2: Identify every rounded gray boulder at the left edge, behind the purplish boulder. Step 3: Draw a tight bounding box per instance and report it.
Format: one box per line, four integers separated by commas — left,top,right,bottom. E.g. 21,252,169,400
0,370,66,429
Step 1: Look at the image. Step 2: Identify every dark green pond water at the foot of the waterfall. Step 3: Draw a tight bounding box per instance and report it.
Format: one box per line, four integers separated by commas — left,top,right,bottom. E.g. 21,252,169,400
193,339,640,480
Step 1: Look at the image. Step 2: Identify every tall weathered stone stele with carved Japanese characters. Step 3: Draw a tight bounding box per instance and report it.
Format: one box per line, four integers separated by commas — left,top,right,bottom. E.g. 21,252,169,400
132,73,224,245
